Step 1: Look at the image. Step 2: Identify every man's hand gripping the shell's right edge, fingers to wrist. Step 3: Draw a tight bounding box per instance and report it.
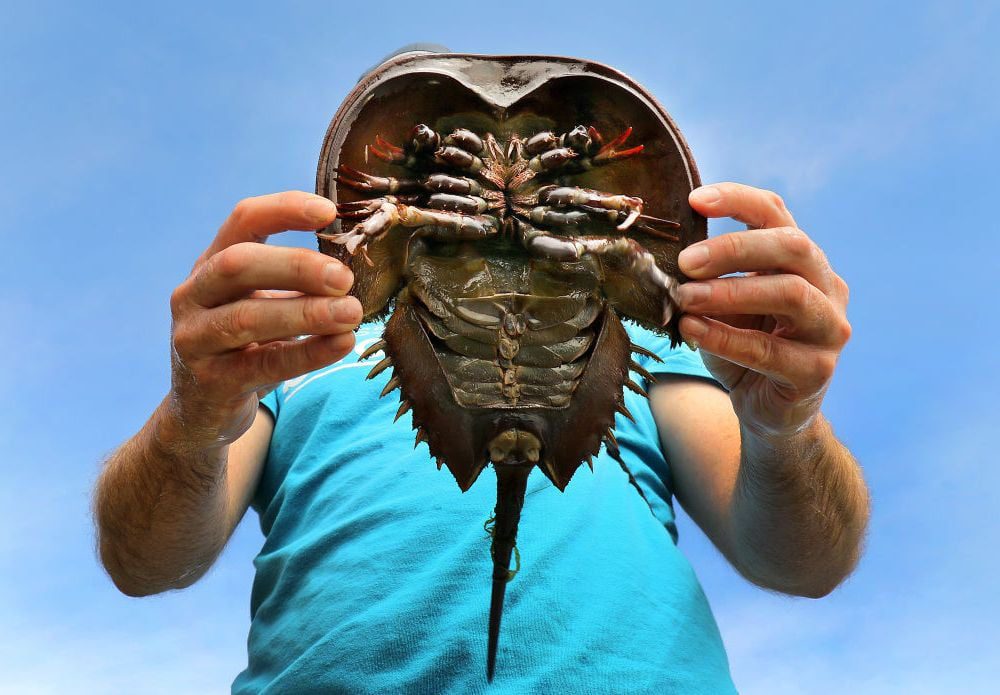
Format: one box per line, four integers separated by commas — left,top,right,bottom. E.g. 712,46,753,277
679,183,851,441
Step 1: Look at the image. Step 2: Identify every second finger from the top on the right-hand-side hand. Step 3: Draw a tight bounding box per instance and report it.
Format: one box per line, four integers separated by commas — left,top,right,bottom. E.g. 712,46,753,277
678,227,834,294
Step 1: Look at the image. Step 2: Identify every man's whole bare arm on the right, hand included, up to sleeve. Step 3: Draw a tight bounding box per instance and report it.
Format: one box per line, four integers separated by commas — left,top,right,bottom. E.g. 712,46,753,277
652,184,869,597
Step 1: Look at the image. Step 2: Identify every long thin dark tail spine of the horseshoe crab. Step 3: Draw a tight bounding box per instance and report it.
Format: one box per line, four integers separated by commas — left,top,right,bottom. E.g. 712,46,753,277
486,459,534,683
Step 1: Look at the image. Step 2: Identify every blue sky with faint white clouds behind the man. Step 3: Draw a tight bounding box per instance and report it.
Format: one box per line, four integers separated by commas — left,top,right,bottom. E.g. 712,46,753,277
0,0,1000,694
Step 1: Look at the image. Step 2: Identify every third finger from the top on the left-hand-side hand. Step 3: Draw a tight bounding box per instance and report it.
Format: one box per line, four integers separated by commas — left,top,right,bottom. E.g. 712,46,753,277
174,297,361,359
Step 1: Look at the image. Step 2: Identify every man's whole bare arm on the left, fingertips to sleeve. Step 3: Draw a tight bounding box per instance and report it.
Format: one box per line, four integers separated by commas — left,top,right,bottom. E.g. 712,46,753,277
94,191,361,596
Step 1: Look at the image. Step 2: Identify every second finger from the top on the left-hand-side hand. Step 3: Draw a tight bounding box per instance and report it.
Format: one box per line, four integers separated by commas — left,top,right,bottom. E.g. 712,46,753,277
189,242,354,307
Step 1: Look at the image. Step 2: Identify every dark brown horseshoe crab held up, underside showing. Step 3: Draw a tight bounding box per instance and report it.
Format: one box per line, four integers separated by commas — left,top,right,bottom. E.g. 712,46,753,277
316,53,707,680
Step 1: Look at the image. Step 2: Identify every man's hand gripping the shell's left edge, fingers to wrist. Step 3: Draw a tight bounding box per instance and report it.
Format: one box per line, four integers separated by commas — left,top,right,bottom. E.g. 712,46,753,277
167,191,362,449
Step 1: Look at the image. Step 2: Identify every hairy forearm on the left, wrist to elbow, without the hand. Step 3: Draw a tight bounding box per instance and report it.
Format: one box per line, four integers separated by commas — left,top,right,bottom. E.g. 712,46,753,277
94,400,228,596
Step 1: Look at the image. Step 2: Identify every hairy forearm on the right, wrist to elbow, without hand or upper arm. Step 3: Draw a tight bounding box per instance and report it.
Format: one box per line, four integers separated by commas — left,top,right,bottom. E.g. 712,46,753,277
730,416,869,598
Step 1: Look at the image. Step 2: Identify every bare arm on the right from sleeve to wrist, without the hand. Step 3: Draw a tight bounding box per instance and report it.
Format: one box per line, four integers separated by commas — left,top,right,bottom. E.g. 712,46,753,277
650,378,868,598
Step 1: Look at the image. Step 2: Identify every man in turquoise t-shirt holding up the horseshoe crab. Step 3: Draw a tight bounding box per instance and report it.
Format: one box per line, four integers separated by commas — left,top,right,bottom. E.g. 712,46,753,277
95,55,868,693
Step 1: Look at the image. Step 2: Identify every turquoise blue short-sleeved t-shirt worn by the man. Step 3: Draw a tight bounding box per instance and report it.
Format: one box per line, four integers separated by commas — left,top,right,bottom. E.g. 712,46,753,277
233,325,735,695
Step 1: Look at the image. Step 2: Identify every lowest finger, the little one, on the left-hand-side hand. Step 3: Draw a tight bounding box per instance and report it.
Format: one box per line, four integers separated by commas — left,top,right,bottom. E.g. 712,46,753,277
225,332,354,392
